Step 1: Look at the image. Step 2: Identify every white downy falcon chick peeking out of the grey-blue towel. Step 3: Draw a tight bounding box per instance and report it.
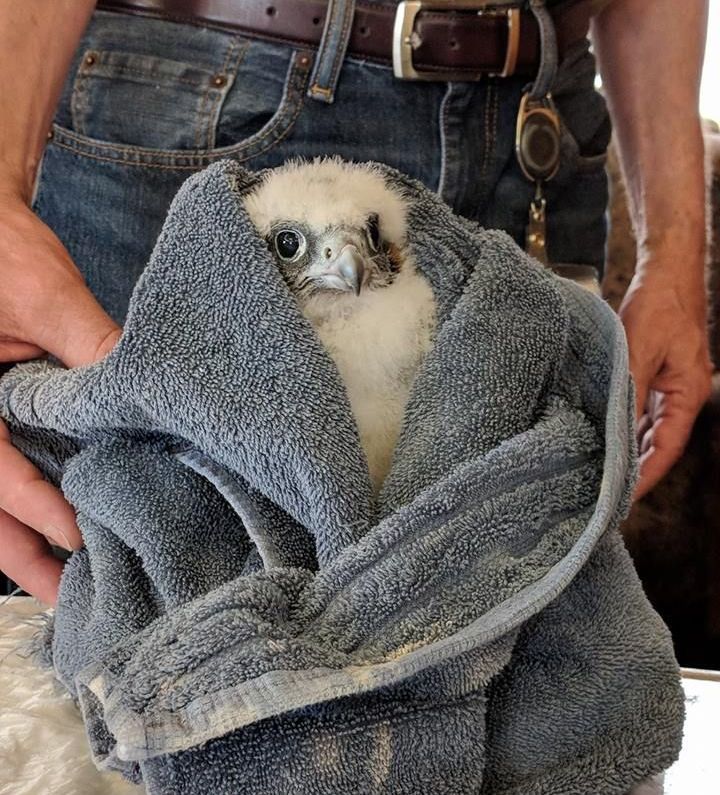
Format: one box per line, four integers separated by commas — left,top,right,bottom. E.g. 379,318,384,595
244,158,436,493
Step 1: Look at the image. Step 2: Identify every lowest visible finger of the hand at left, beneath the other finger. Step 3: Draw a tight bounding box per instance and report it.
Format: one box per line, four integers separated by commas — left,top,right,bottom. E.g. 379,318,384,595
0,511,63,605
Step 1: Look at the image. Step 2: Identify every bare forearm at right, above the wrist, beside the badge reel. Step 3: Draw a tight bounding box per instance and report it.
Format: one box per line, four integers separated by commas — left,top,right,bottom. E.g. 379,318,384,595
593,0,707,287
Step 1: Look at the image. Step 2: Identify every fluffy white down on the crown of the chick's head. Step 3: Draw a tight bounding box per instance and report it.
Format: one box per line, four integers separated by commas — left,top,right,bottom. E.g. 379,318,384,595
244,158,405,246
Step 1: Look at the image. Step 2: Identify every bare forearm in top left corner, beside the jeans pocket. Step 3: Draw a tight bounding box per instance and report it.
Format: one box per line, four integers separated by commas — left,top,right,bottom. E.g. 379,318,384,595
0,0,95,201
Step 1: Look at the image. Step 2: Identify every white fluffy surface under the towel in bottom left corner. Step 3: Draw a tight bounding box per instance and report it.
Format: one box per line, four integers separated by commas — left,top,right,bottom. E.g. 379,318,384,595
0,597,145,795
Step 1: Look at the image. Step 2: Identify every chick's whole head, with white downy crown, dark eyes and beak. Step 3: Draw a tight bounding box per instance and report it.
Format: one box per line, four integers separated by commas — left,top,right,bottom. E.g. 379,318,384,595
244,158,405,304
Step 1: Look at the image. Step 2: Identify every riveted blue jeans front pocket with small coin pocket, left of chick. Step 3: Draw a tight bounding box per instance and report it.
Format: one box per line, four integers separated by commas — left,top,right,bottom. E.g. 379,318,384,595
65,52,312,171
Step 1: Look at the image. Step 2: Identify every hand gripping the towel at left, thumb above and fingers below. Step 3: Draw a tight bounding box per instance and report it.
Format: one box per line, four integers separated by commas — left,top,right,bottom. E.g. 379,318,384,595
0,195,120,604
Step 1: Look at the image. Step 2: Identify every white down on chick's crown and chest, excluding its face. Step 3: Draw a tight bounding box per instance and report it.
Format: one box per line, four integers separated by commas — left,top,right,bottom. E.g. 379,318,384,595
244,158,435,491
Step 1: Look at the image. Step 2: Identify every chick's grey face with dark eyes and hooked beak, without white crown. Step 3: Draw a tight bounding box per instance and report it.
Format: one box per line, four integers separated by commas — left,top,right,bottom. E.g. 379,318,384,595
267,213,399,299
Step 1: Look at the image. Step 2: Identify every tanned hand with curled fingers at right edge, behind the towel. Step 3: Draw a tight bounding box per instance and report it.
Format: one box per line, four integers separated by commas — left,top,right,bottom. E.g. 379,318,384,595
619,263,712,500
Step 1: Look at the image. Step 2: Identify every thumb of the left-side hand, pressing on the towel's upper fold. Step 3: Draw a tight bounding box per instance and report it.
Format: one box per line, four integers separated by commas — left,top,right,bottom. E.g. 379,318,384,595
36,284,122,367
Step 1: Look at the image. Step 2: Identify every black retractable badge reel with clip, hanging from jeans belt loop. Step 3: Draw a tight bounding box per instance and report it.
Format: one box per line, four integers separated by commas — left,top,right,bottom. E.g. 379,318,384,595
515,0,560,266
